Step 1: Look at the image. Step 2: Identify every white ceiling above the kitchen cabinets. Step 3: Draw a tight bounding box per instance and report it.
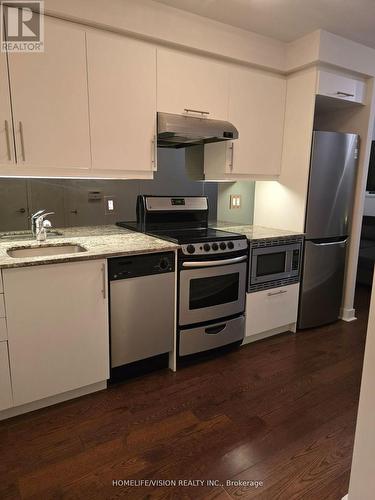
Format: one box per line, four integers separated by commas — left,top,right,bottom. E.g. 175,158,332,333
158,0,375,48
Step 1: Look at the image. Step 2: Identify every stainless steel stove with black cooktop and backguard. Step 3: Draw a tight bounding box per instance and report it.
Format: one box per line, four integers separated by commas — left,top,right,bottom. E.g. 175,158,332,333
118,195,248,357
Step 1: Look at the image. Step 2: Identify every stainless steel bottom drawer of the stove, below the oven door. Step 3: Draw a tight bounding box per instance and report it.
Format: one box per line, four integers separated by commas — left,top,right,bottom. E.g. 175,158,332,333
179,316,245,356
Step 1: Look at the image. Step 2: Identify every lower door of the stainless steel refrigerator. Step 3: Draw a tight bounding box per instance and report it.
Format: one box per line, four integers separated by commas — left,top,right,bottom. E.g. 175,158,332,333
298,240,347,328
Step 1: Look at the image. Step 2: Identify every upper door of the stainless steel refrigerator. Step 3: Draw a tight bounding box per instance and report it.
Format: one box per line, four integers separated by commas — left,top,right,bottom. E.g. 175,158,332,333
305,132,358,239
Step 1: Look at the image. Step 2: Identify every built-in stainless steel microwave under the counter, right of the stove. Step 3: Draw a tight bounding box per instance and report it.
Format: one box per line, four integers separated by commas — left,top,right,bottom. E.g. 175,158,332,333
248,236,303,292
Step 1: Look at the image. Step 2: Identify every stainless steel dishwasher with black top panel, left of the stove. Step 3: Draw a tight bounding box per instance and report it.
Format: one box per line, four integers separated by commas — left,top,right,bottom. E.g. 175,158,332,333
108,252,175,379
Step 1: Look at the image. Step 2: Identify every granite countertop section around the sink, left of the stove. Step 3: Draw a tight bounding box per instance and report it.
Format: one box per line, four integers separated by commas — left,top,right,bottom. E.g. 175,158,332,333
0,225,179,269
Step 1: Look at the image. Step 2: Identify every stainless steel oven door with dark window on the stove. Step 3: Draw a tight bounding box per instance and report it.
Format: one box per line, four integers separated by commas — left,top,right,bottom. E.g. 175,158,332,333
179,256,247,326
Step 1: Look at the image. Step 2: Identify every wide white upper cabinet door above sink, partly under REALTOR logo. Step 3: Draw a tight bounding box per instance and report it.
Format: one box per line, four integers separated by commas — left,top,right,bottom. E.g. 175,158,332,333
8,17,91,170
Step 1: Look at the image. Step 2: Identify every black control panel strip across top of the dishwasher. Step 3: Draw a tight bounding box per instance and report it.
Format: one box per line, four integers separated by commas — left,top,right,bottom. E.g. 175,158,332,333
108,252,175,281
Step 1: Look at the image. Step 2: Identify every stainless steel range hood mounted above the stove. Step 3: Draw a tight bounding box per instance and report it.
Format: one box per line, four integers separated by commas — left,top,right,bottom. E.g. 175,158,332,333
158,113,238,148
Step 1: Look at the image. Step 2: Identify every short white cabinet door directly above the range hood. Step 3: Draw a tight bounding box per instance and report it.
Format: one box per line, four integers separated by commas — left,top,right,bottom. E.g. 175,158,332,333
158,49,229,120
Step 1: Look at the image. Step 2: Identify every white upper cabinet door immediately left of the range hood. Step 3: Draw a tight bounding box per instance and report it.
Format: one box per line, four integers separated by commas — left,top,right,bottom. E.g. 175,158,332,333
87,32,156,172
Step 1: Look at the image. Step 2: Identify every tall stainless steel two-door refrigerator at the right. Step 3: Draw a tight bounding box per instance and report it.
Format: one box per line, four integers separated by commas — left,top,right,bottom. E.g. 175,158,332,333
298,132,358,328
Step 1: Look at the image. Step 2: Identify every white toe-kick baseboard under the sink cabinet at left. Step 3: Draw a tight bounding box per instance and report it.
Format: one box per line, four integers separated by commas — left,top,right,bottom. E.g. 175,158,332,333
0,380,107,420
